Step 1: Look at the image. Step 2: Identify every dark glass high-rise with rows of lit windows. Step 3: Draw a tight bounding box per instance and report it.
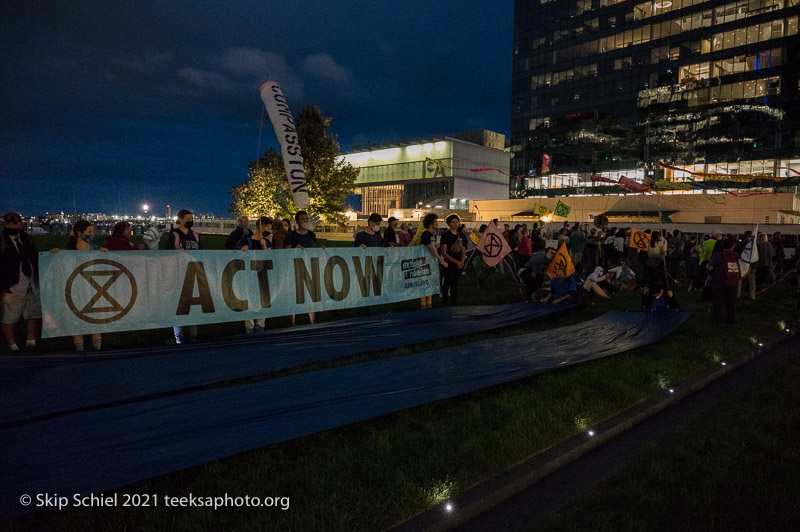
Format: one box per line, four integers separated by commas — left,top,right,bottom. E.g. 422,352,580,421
510,0,800,197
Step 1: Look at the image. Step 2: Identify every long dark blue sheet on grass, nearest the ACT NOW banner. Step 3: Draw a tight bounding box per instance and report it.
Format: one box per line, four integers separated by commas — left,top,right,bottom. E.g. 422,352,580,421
0,303,572,424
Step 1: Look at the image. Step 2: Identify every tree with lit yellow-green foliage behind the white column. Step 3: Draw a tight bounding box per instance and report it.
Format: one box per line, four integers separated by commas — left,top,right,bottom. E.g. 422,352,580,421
229,105,359,223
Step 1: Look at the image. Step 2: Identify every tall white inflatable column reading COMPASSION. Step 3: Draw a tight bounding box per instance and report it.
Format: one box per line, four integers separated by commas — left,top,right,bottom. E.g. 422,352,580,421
259,81,308,209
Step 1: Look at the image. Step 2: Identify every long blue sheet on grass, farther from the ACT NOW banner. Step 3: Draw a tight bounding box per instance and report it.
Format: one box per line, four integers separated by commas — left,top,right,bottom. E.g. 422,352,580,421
0,311,688,517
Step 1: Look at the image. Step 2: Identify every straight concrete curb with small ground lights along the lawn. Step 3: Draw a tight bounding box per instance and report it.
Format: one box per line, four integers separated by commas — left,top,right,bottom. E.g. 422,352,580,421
391,322,800,532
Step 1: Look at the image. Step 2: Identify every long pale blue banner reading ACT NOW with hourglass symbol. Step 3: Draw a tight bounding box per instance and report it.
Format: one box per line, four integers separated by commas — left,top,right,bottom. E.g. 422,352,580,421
39,246,439,338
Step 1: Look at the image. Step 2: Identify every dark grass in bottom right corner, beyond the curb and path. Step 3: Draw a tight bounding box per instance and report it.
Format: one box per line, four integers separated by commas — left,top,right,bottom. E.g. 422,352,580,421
537,332,800,531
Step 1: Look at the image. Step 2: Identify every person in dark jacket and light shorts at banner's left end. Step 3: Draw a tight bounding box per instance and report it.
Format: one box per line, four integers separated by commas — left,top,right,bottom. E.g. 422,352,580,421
0,212,42,351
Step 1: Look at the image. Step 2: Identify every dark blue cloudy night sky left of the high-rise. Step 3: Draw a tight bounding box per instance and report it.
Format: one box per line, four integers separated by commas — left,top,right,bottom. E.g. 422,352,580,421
0,0,513,216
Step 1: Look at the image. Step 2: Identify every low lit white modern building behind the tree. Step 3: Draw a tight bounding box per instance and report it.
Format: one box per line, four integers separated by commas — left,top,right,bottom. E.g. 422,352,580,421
343,130,509,216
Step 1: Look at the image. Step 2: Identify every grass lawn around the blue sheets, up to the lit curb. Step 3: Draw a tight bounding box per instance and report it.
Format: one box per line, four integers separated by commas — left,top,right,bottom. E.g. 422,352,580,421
4,239,797,530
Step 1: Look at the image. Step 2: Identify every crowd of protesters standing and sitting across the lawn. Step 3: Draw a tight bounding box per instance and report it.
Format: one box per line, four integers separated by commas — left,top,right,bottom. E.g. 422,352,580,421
0,209,800,352
